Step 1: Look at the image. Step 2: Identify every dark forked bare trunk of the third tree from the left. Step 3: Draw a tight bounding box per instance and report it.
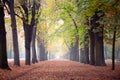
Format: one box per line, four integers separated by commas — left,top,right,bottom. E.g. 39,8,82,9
21,1,36,65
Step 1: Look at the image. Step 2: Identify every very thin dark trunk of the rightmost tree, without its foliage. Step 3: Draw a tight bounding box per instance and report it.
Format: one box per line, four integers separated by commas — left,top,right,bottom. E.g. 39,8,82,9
112,27,116,70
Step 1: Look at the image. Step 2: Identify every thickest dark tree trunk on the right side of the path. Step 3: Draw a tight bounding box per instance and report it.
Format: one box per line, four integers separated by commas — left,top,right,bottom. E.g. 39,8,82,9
95,29,106,66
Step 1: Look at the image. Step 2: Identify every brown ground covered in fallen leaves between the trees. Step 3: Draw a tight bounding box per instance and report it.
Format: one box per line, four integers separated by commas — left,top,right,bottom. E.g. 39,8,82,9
0,60,120,80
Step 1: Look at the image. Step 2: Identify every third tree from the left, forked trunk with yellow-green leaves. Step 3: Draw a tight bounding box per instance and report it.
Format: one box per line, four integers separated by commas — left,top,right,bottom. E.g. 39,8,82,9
18,0,39,65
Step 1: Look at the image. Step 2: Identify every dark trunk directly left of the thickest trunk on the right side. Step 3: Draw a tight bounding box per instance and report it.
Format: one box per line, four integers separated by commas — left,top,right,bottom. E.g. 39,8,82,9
88,30,95,65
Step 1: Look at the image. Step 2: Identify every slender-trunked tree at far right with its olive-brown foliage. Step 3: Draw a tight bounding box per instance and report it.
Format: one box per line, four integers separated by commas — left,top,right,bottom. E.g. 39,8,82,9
101,0,120,70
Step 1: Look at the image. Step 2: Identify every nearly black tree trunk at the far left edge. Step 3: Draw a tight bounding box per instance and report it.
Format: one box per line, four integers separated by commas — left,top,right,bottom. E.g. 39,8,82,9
0,0,10,70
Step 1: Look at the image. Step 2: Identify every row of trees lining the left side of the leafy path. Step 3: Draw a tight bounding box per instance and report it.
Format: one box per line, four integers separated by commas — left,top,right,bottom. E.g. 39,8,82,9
0,0,46,69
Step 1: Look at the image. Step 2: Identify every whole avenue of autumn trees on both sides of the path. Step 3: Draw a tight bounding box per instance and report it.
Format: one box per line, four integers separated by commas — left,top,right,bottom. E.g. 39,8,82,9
0,0,120,70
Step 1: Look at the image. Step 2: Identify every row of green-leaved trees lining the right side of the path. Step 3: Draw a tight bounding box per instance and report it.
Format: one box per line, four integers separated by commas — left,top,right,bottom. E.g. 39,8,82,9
55,0,120,70
